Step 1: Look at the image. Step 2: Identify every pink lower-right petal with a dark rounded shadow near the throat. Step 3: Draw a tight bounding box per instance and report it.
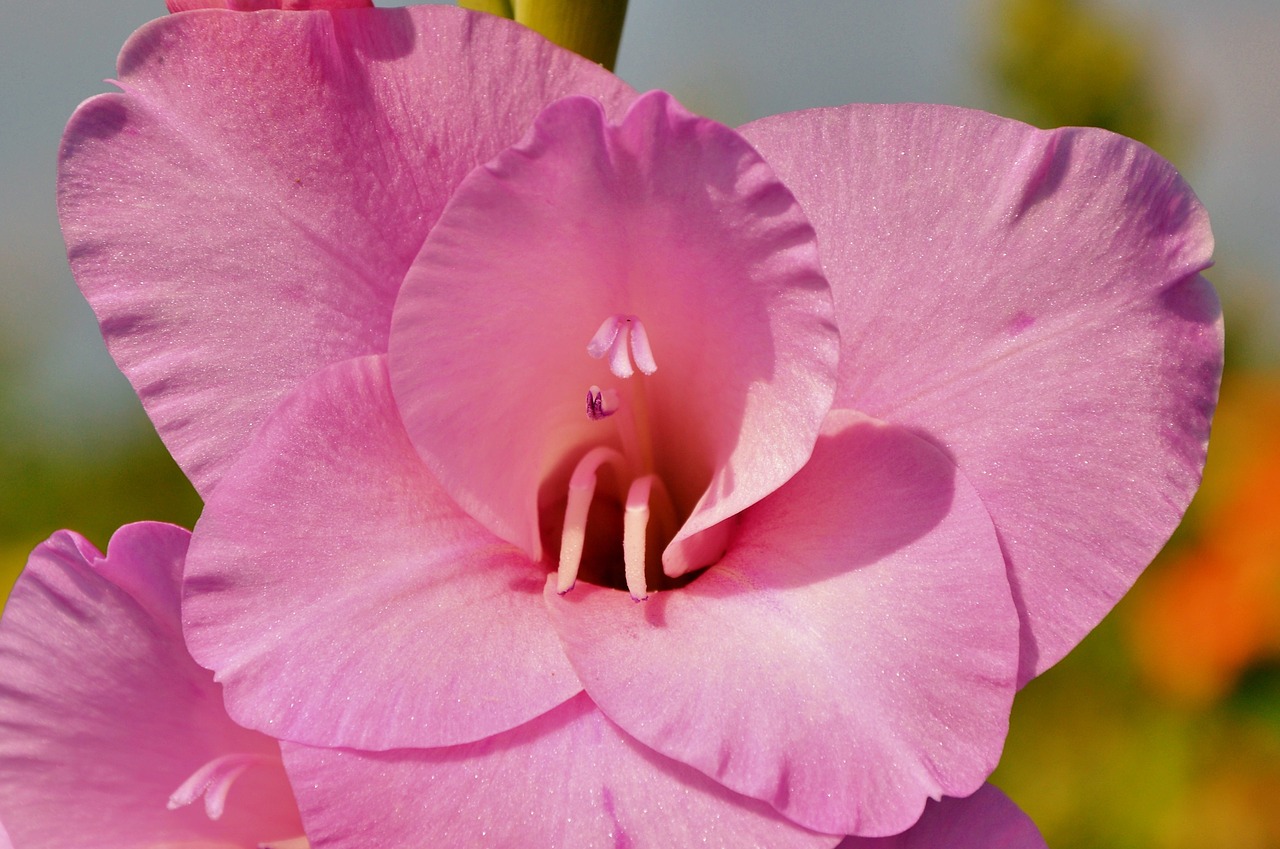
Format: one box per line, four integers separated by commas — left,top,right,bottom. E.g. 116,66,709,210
548,411,1018,835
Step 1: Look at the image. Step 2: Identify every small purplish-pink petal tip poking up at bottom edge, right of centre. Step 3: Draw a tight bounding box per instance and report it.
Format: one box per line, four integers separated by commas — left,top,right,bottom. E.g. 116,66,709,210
837,784,1047,849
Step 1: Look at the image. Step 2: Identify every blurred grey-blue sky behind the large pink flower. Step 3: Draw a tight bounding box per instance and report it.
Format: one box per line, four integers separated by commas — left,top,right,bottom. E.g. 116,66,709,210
0,0,1280,451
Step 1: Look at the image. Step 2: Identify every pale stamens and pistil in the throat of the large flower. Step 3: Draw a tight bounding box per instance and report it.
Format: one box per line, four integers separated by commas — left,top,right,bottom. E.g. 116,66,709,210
556,314,678,602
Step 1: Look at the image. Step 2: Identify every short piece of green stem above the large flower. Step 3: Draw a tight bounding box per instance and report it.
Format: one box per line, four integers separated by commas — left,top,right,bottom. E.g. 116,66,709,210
458,0,627,70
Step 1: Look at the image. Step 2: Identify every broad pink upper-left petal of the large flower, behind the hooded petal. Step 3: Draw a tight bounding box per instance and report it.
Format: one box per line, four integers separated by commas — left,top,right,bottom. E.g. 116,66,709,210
59,6,634,493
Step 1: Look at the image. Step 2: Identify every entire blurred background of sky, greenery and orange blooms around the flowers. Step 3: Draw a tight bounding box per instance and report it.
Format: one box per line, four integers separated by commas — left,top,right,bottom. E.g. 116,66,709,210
0,0,1280,849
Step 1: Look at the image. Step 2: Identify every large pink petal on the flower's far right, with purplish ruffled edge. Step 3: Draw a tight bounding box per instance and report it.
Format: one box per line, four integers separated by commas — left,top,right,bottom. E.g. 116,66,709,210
742,106,1222,681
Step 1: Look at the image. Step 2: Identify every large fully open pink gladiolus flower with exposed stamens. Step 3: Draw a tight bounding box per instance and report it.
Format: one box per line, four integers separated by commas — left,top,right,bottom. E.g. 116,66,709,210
60,8,1221,846
